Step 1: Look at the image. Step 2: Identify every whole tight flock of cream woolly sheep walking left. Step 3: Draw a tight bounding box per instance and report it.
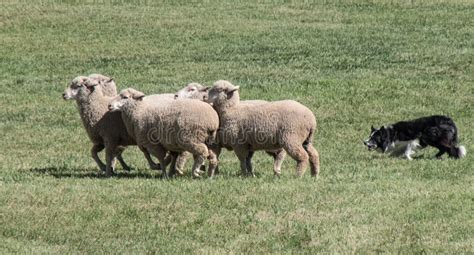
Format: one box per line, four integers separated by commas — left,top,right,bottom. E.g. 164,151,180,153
63,74,320,178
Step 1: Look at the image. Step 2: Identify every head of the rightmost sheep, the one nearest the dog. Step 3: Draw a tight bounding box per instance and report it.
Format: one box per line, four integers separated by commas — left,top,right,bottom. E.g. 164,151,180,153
207,80,240,107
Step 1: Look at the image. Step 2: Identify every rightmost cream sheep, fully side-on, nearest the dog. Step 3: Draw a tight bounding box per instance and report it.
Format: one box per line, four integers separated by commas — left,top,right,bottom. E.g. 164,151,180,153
208,80,319,176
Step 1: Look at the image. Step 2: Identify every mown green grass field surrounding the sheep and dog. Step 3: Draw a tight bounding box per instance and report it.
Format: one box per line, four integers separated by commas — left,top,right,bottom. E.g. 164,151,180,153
0,0,474,254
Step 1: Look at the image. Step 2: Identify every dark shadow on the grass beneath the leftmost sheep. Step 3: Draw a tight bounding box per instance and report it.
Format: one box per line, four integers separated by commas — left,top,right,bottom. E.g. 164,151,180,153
27,167,161,179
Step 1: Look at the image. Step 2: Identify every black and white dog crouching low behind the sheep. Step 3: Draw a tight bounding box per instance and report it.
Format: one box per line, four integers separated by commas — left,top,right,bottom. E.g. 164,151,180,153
364,115,466,160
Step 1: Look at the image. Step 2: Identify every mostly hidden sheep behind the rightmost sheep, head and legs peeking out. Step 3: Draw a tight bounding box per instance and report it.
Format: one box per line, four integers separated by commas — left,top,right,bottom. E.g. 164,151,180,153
175,83,286,176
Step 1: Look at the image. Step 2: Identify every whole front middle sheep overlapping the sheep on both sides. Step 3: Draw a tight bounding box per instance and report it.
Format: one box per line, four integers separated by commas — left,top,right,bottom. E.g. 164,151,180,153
109,88,219,178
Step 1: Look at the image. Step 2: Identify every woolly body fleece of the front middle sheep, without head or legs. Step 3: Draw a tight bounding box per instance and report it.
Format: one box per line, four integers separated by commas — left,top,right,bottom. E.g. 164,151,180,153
122,95,219,152
